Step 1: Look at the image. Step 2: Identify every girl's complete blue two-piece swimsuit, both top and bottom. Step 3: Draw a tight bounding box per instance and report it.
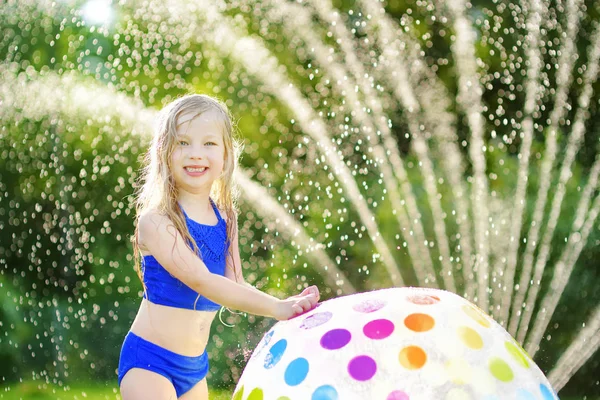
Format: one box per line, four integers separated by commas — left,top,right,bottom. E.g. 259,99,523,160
119,199,228,397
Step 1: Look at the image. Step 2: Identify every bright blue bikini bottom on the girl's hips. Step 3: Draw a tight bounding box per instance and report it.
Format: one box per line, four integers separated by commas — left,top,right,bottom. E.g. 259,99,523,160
119,331,208,397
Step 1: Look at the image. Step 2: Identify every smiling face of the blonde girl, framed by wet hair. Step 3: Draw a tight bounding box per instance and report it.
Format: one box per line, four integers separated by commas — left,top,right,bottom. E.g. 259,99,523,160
171,110,225,194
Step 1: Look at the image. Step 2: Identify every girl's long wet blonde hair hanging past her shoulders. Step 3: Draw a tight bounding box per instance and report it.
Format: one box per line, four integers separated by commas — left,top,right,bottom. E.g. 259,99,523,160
132,94,242,308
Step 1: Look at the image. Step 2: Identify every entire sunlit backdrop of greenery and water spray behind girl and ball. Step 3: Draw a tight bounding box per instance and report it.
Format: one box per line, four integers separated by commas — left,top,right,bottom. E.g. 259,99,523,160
0,0,600,399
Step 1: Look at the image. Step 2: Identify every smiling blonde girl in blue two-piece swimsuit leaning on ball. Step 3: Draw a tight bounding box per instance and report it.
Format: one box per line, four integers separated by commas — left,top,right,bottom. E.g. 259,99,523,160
119,95,319,400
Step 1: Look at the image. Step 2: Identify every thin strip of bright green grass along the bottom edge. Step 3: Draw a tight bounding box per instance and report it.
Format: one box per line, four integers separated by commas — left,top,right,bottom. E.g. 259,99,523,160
0,382,232,400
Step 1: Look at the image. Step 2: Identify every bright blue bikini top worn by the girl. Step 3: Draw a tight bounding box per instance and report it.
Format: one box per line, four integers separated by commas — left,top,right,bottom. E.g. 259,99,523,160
142,199,228,311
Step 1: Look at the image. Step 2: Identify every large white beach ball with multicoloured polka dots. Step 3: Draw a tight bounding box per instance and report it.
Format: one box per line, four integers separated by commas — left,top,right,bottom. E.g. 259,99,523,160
233,288,557,400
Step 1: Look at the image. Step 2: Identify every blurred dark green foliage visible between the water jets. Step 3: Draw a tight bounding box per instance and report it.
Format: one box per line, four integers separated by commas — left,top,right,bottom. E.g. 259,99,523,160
0,0,600,395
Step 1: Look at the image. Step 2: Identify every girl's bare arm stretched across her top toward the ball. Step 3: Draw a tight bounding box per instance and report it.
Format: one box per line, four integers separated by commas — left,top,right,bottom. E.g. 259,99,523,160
138,212,318,320
